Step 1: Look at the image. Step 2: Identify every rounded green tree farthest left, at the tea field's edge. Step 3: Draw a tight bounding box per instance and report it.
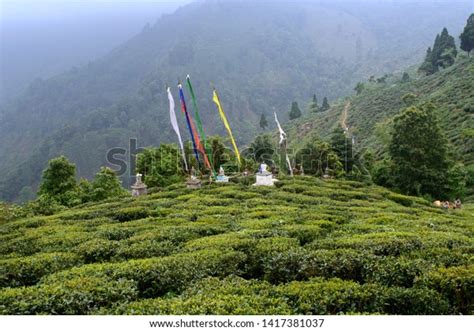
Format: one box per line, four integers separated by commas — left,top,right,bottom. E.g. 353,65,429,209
38,156,76,201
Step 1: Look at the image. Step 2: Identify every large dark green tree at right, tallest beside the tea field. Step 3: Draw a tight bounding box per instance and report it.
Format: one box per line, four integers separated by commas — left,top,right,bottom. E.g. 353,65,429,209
389,104,449,197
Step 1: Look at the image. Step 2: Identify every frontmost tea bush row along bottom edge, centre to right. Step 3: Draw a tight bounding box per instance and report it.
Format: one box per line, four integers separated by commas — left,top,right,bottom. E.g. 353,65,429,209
106,277,452,315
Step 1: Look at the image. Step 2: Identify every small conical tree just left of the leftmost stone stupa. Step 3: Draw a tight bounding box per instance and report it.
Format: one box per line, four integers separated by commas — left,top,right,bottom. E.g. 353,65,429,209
91,167,126,201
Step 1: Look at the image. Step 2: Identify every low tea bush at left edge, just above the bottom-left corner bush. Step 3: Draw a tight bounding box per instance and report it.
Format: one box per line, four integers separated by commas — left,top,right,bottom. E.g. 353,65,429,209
0,253,82,287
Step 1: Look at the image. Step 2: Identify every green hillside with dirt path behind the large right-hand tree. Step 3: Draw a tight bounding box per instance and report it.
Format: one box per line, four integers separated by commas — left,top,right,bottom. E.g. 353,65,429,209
288,57,474,165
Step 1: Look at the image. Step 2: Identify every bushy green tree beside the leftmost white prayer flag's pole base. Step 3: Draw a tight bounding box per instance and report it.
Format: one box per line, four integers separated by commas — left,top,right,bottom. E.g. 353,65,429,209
137,144,184,187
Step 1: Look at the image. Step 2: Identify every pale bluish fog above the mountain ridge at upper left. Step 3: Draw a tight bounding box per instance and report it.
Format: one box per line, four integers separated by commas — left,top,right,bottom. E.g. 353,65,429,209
0,0,191,102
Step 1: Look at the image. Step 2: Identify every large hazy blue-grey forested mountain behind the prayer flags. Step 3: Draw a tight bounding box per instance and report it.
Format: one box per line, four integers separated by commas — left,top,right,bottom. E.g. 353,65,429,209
0,1,470,200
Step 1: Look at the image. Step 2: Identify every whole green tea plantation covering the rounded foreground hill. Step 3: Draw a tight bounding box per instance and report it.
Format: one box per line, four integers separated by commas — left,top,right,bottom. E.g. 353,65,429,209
0,177,474,314
